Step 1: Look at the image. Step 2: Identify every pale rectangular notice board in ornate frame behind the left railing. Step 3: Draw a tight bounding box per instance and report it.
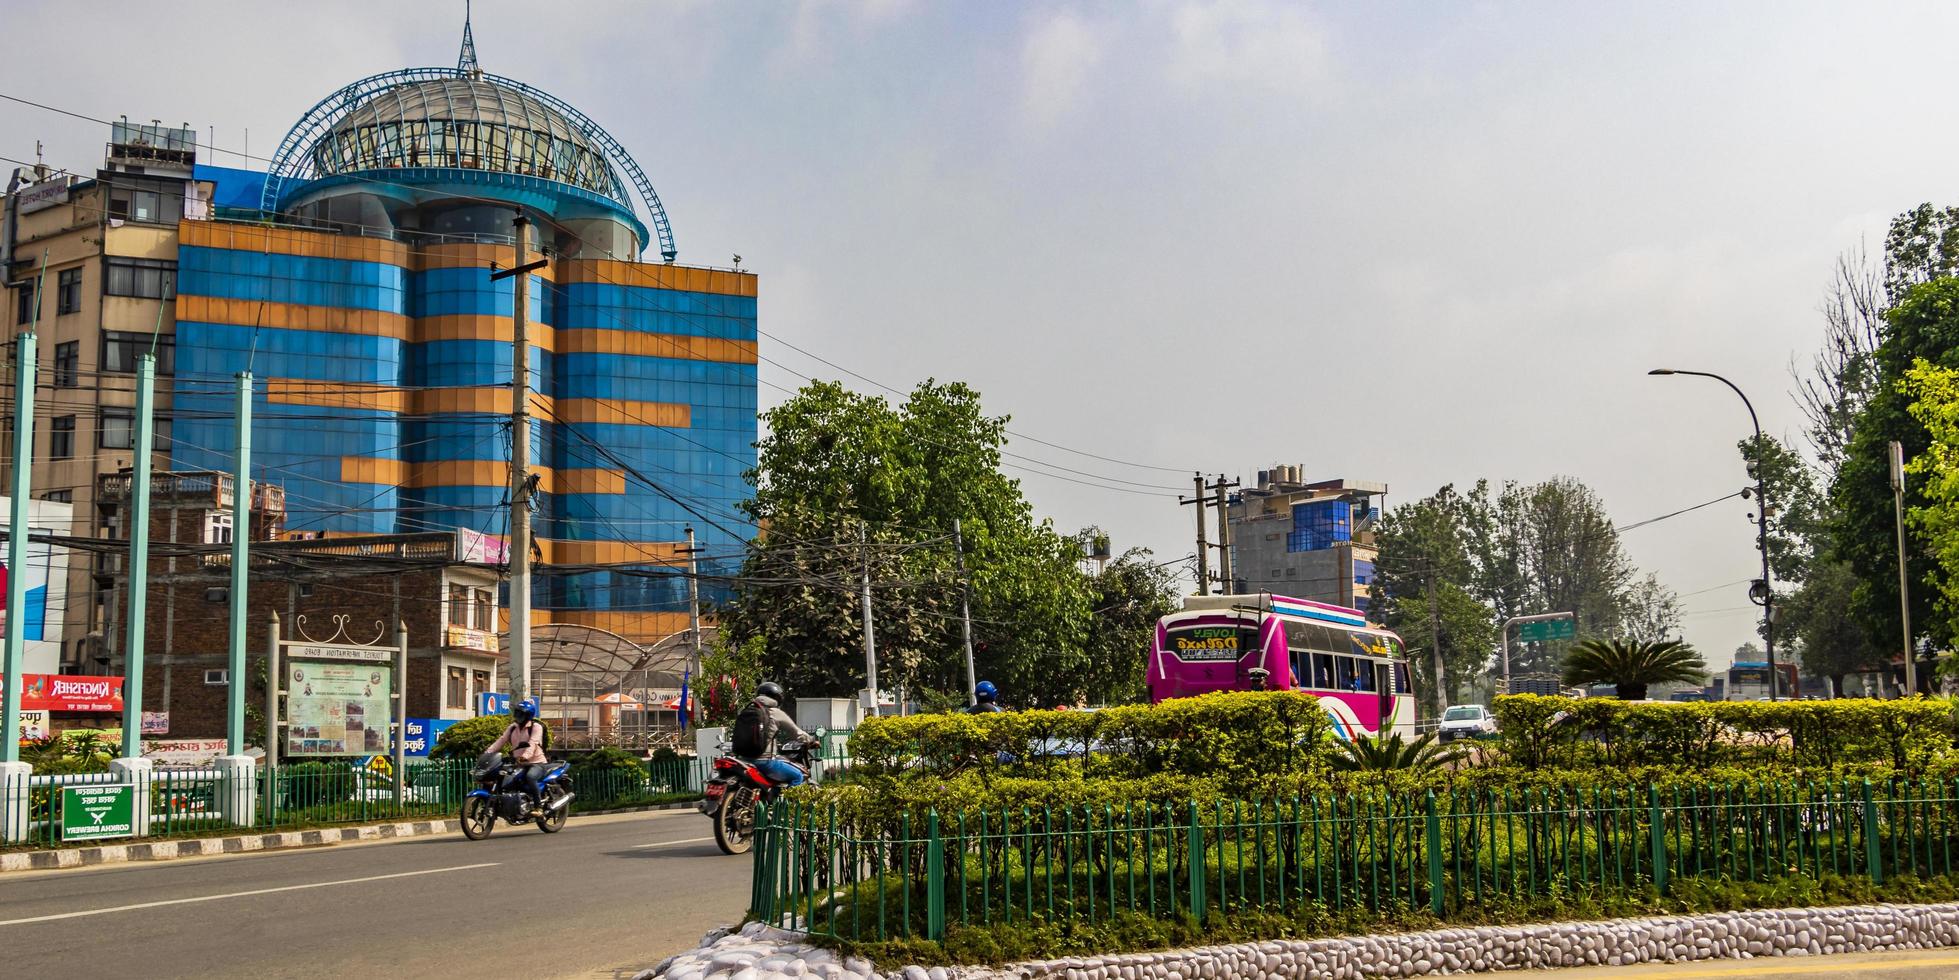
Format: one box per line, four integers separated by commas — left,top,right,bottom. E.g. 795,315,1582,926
286,661,394,757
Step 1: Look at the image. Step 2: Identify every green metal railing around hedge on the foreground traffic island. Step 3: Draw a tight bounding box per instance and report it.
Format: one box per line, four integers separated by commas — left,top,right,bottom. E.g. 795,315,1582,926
750,782,1959,941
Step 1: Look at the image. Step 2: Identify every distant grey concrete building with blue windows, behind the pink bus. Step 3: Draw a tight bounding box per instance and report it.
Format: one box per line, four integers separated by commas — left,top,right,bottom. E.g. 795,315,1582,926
1226,465,1387,612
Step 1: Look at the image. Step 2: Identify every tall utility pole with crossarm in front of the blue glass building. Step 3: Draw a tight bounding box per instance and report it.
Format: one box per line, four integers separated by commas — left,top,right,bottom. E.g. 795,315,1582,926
490,212,550,704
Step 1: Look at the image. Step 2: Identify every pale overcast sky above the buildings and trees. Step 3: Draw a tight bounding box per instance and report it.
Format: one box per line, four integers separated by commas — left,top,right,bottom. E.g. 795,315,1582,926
0,0,1959,661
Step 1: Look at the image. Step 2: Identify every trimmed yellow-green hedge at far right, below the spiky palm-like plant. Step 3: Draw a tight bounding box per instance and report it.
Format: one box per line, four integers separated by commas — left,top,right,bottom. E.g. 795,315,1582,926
1495,694,1953,774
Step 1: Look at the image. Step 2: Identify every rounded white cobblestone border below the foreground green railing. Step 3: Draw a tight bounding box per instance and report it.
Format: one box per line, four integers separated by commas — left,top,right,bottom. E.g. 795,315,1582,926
650,904,1959,980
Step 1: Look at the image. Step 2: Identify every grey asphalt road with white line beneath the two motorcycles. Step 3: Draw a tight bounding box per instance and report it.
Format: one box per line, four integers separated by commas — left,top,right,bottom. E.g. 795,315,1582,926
0,809,748,980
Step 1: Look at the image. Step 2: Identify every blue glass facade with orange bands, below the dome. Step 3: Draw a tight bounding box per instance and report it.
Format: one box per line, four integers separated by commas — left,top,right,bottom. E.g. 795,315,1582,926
172,221,756,641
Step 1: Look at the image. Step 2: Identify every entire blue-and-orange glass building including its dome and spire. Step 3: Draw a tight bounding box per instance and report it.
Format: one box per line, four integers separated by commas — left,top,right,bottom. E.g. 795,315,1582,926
172,29,756,643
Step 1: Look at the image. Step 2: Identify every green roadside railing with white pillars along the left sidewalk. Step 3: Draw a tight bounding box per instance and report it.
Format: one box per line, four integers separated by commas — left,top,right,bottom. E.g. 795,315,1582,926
0,759,701,849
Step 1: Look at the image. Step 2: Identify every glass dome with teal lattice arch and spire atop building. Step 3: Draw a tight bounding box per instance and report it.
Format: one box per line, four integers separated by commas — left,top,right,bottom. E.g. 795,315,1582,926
259,25,676,263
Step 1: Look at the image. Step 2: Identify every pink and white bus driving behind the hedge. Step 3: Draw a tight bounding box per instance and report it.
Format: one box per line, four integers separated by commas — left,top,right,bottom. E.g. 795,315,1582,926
1148,592,1414,739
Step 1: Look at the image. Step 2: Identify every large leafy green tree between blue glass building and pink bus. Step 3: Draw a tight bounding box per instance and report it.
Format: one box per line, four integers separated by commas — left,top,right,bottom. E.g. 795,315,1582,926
723,380,1093,704
